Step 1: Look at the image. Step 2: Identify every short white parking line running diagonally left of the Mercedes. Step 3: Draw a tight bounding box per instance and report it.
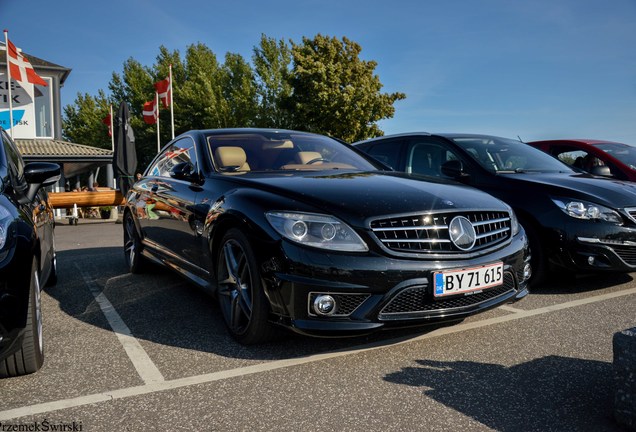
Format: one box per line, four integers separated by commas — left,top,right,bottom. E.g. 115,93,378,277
75,263,165,384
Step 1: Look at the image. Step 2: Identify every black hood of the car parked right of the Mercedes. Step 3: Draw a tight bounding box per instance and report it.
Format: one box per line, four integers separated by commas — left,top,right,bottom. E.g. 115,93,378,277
497,173,636,208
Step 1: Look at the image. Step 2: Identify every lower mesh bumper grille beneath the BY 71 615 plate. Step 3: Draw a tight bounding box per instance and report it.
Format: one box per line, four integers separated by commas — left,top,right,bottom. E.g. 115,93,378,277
378,272,516,321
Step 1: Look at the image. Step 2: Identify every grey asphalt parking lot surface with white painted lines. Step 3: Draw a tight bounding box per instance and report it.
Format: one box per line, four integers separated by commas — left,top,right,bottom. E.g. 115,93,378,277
0,220,636,432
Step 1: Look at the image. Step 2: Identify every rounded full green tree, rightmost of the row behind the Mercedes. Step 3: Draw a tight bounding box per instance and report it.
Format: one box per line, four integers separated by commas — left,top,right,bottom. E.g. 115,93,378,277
286,34,406,142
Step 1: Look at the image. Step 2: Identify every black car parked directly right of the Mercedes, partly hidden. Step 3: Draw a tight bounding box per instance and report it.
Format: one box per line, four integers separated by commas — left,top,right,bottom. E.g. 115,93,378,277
354,132,636,287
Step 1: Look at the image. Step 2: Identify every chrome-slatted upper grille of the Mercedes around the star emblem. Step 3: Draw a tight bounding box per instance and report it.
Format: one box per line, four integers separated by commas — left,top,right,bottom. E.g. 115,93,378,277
371,211,512,253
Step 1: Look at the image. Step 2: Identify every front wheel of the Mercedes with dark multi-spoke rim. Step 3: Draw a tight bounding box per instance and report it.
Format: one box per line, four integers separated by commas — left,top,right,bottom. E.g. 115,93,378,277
216,228,278,345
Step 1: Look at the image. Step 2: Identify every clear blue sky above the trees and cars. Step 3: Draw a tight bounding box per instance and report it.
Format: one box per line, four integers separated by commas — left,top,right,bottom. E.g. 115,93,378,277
0,0,636,145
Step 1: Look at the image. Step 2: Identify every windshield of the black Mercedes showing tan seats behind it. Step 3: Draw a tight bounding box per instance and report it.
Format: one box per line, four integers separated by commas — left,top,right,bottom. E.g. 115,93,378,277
207,130,379,173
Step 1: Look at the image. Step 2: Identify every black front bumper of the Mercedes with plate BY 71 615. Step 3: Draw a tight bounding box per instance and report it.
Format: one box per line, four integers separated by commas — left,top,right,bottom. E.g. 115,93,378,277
263,234,529,337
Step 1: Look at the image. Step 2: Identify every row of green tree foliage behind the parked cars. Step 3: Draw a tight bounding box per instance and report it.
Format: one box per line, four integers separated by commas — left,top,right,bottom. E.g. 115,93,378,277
63,34,405,166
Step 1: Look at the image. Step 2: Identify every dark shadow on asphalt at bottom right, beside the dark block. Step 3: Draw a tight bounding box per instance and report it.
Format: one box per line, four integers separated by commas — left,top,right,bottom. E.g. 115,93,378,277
384,356,618,432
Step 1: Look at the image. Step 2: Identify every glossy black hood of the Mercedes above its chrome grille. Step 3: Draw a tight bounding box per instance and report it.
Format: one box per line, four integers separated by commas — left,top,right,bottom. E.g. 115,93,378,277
226,172,507,224
